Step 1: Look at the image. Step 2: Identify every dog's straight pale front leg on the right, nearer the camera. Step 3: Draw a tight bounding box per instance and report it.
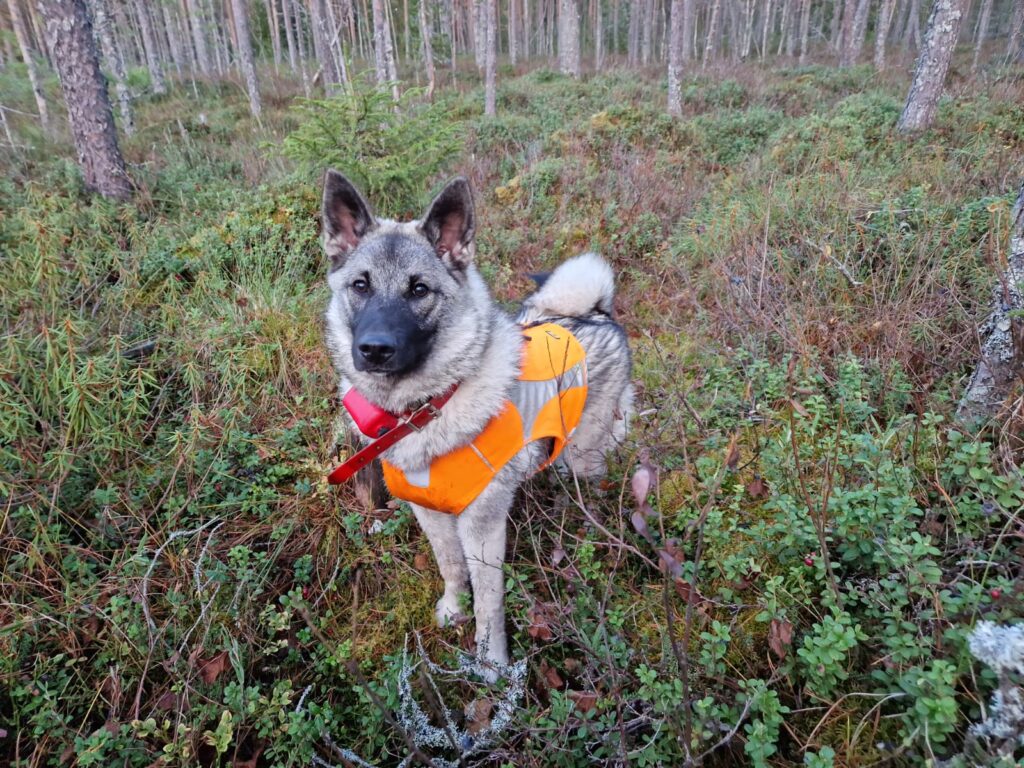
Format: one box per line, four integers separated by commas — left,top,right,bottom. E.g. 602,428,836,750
456,482,515,682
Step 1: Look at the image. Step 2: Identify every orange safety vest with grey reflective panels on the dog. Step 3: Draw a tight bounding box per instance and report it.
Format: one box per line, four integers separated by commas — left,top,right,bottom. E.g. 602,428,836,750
382,323,587,515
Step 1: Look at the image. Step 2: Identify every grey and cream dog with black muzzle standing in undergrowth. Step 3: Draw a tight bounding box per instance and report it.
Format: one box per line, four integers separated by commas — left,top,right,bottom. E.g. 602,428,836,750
322,170,633,681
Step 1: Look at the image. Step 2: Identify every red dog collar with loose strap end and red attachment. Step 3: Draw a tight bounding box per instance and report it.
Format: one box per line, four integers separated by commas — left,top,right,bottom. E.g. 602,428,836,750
327,384,459,485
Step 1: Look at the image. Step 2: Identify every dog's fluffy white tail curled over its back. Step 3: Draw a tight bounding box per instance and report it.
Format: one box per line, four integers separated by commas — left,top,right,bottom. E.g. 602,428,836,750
519,253,615,324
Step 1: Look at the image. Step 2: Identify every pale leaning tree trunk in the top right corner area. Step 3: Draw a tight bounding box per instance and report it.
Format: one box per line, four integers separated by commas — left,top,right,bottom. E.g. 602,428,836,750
897,0,964,133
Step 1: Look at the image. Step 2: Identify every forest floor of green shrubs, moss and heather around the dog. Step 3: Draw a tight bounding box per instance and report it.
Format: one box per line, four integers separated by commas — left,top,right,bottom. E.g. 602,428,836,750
0,57,1024,768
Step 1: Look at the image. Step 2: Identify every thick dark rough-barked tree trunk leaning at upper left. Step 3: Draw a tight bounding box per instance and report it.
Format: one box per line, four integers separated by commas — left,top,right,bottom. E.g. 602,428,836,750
39,0,131,200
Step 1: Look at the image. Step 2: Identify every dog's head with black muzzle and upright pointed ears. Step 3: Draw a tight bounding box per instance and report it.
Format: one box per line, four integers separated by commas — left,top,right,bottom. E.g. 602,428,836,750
323,171,487,406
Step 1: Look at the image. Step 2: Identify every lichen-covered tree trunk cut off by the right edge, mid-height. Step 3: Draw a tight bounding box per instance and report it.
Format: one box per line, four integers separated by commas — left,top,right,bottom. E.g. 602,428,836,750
956,184,1024,425
